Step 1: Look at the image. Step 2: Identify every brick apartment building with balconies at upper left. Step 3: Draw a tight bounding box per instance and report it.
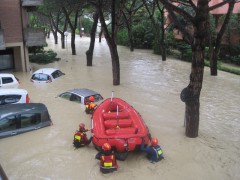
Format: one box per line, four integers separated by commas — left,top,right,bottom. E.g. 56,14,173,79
0,0,46,71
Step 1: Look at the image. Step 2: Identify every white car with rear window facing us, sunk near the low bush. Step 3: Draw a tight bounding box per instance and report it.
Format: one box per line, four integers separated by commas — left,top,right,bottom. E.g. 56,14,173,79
31,68,65,83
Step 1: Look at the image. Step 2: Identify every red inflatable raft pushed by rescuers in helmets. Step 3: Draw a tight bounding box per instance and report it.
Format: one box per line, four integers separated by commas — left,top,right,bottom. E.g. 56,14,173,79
92,98,150,152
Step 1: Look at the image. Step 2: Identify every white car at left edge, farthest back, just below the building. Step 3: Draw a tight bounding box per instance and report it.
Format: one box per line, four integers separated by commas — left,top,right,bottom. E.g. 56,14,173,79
0,73,20,89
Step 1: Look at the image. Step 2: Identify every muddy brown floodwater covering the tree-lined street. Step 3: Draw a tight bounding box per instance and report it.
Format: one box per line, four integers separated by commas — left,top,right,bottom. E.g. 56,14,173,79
0,34,240,180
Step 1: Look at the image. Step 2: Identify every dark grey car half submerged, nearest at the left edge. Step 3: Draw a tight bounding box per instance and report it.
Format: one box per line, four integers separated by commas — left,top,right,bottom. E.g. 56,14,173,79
0,103,52,138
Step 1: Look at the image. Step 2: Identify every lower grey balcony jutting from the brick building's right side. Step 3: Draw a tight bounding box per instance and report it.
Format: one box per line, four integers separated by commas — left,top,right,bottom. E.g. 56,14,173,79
24,28,47,47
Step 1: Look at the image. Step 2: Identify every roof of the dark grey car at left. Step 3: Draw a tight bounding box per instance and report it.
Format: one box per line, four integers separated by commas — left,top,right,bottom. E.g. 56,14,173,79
0,103,47,119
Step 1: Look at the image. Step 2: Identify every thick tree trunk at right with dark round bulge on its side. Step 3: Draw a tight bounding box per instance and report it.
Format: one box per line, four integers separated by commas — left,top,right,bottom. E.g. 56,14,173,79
182,0,209,138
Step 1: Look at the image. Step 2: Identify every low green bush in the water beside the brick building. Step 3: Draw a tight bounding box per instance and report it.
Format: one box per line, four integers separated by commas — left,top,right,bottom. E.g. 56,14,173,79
29,50,60,64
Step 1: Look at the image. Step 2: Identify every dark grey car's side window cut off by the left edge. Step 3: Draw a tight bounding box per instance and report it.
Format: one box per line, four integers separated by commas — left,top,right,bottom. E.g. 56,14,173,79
0,116,17,132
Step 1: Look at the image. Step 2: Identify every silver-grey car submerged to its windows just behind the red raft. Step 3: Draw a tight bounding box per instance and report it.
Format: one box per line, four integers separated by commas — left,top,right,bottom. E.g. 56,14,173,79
59,89,103,105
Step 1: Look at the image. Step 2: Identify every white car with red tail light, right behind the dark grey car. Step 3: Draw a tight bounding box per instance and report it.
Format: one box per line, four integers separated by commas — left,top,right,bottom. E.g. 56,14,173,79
0,88,30,105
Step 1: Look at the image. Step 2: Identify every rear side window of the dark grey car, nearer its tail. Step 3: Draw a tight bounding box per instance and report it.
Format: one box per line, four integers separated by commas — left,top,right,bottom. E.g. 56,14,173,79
21,113,41,128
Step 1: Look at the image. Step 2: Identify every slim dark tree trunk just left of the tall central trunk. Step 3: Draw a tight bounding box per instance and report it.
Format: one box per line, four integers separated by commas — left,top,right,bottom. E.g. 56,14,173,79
86,13,98,66
